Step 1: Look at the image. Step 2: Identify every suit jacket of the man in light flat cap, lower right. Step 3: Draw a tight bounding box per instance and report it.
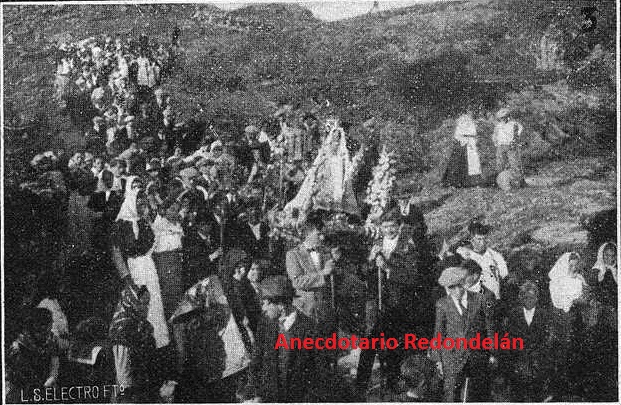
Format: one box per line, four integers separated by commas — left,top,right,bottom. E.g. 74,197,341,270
431,291,493,379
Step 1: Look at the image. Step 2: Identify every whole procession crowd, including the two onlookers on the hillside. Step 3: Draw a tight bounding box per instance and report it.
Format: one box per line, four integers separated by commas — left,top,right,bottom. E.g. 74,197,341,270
5,31,618,402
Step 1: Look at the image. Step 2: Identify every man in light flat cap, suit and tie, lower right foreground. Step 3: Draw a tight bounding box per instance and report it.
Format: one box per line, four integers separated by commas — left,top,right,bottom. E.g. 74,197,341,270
430,267,496,402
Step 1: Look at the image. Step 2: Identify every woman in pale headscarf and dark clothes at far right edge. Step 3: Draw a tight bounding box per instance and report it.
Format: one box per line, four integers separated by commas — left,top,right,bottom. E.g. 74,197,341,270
591,242,618,327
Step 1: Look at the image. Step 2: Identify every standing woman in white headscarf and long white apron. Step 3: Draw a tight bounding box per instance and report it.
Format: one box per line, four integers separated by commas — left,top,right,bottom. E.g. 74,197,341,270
111,176,170,349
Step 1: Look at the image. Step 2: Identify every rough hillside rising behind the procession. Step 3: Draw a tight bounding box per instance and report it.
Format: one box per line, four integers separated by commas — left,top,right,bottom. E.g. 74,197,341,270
3,0,616,260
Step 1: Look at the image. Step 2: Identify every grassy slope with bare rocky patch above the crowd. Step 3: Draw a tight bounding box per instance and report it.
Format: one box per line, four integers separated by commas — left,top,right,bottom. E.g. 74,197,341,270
4,0,616,266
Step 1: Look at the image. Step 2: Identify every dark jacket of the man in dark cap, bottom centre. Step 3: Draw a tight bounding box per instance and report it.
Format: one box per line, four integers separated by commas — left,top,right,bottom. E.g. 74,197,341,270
250,312,327,402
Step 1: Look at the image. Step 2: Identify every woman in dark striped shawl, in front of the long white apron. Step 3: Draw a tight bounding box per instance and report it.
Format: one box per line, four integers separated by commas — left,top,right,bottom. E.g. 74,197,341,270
108,283,158,402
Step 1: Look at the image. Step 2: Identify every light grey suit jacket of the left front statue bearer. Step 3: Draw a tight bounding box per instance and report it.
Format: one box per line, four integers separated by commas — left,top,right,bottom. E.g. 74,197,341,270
286,245,331,321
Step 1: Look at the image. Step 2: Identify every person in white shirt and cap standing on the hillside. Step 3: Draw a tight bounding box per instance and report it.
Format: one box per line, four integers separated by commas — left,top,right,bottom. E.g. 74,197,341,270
492,108,524,175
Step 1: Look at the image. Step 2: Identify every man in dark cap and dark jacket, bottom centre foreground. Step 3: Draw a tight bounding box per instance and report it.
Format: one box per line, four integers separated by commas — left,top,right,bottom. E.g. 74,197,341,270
248,276,326,402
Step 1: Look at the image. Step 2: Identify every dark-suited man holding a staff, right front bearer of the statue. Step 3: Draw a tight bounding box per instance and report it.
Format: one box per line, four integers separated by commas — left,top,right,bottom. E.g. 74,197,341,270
357,207,433,393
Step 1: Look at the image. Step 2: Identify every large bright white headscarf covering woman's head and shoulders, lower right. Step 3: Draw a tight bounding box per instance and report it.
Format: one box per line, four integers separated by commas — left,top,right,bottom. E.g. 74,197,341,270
548,252,586,312
